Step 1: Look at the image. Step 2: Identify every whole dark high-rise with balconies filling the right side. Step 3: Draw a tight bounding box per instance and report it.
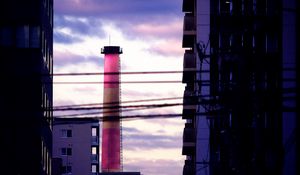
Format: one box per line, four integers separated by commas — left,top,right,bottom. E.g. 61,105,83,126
182,0,299,175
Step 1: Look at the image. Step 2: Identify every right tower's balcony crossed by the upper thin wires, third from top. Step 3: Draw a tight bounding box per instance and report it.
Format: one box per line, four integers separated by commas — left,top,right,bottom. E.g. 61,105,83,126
182,50,197,83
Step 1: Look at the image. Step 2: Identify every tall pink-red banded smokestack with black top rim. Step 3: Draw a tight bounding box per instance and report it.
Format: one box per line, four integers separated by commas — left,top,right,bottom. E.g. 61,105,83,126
101,46,122,172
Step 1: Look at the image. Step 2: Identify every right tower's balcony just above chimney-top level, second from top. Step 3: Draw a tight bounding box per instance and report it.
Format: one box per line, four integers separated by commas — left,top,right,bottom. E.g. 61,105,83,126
182,13,196,48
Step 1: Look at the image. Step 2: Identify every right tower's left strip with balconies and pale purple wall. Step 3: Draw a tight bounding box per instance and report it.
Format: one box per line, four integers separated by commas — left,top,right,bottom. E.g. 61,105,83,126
182,0,212,174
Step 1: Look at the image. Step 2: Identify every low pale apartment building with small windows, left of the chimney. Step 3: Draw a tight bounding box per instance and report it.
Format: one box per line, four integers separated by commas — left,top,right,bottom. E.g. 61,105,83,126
53,118,100,175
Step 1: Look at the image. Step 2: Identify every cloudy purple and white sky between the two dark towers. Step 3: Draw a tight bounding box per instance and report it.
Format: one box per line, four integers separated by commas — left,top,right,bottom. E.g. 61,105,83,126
54,0,185,175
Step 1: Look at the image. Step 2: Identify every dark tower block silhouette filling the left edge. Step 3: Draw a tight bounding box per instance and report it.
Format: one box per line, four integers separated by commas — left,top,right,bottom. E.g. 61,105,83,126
0,0,53,175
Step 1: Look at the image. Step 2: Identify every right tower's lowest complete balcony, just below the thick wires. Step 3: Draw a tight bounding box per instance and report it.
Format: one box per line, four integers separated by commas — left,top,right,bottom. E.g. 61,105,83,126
182,123,196,155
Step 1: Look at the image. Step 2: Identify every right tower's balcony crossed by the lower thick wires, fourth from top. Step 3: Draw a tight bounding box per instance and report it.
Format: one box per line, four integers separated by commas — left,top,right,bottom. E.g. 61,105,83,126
182,88,198,119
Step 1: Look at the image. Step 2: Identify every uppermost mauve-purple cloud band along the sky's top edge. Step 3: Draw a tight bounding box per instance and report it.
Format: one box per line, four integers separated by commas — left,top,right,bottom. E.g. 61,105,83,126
54,0,182,20
